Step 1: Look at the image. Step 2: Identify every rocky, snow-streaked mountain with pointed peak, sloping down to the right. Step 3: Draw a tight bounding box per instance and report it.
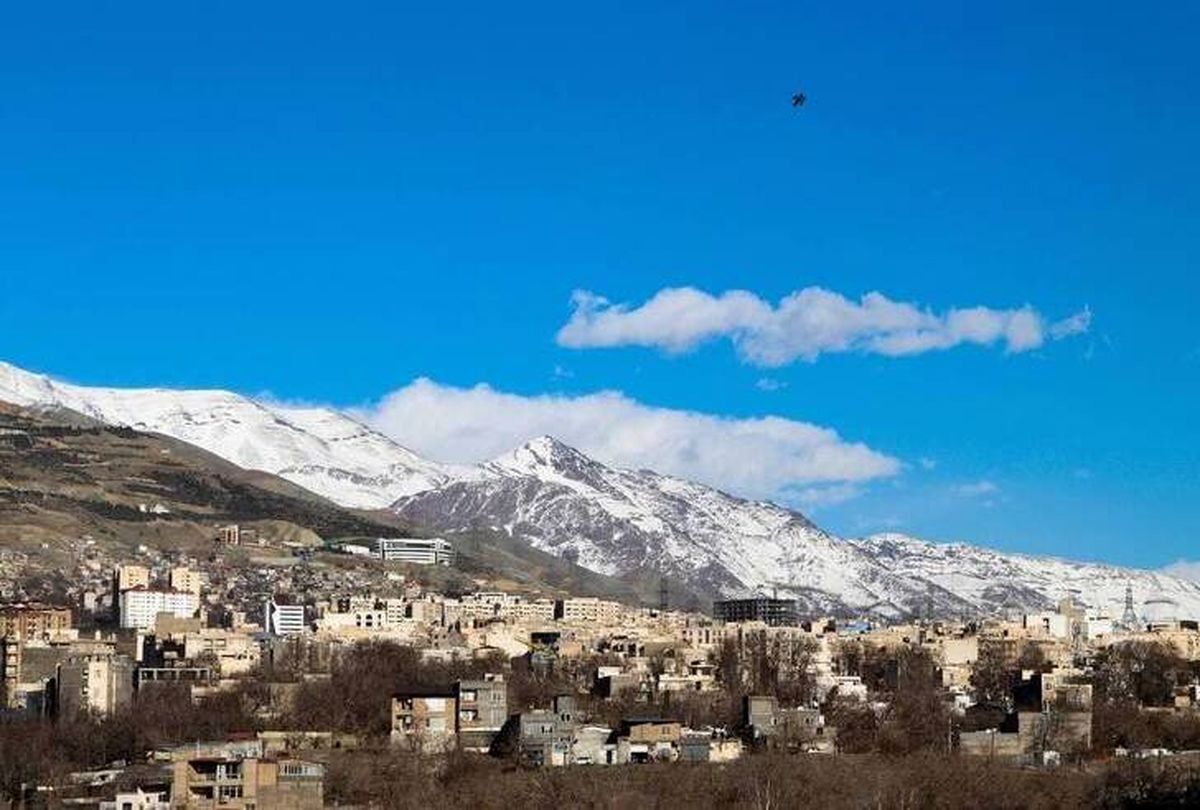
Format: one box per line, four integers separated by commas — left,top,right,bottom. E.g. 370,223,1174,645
395,437,1200,617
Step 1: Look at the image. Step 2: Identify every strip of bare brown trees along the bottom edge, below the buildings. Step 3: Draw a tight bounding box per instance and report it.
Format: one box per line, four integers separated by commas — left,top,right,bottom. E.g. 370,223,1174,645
316,749,1113,810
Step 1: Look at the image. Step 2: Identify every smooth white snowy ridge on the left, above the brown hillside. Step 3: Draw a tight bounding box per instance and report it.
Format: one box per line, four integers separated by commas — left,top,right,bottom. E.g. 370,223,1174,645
0,362,450,509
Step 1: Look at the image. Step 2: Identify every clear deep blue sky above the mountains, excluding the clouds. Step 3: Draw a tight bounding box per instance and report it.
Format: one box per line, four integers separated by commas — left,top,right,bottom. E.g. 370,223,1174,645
0,2,1200,565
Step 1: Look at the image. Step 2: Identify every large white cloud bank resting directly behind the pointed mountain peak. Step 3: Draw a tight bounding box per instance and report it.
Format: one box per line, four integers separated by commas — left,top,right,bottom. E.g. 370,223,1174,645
356,379,901,503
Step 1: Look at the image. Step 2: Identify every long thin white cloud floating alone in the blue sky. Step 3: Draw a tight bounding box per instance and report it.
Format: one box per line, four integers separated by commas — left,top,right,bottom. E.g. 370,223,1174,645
557,287,1092,367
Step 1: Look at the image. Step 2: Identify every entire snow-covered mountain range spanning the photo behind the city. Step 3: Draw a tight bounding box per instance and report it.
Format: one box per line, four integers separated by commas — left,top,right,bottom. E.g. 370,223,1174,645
0,364,1200,618
